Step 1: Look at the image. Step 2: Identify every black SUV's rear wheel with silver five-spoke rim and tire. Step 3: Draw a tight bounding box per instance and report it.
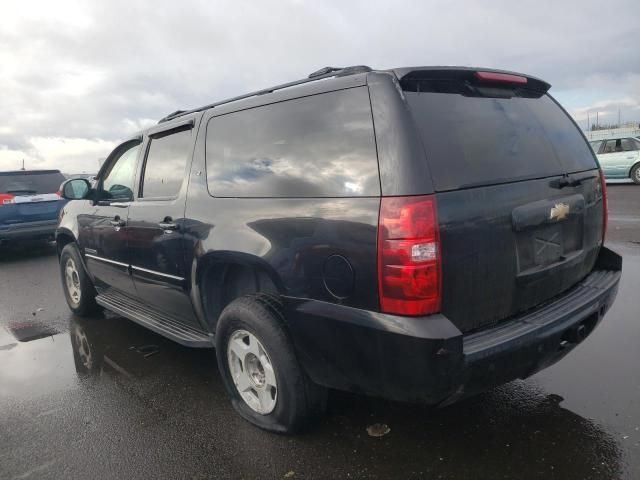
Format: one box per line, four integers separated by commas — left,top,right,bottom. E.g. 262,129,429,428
216,294,327,433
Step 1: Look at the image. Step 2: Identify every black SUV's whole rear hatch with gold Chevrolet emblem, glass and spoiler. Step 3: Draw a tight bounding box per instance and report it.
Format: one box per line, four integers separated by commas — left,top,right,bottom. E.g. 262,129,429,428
400,69,604,332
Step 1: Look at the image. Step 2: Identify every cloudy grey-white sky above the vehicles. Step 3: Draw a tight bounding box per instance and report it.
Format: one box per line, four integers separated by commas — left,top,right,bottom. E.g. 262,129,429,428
0,0,640,172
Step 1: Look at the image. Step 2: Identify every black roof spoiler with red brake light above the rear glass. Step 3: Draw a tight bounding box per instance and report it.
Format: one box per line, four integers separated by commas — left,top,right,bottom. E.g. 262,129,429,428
393,67,551,95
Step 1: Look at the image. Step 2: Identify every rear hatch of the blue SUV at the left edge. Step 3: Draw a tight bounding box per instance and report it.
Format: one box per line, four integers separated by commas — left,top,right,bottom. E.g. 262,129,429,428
0,170,65,229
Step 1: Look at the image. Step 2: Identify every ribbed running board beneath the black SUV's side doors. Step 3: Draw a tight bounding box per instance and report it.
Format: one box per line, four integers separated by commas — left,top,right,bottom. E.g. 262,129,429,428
96,289,214,348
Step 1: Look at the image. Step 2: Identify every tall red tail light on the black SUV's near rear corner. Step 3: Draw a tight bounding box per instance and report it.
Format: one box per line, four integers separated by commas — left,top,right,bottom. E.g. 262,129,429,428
378,195,441,315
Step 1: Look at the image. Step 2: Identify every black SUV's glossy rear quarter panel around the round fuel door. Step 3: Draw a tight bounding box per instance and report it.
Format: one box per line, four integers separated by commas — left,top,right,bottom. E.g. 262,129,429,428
185,188,379,309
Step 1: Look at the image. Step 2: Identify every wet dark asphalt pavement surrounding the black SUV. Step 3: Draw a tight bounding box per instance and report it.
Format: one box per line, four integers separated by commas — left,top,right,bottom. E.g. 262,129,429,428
0,185,640,479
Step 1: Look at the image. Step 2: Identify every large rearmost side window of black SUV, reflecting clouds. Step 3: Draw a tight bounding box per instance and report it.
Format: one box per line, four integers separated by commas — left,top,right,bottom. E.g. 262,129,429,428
206,87,380,197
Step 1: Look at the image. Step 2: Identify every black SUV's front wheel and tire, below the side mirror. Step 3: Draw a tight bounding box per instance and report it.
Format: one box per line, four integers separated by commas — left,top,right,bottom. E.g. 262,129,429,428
60,243,99,317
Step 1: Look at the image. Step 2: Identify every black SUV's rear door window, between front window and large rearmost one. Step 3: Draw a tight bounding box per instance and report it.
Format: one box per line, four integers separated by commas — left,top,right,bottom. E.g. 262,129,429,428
140,126,191,198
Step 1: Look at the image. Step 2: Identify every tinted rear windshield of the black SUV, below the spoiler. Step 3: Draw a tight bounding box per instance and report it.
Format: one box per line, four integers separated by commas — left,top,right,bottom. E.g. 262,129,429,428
405,91,597,191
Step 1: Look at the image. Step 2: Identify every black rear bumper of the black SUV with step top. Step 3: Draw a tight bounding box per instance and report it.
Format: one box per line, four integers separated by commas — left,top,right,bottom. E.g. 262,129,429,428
286,248,622,404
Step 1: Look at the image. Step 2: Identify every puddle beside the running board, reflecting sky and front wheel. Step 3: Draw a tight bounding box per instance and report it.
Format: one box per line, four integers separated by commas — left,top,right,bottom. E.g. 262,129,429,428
0,316,208,402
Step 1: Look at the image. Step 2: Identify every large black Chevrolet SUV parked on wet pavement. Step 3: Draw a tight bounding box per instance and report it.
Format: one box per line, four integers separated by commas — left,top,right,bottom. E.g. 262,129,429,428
57,67,622,432
